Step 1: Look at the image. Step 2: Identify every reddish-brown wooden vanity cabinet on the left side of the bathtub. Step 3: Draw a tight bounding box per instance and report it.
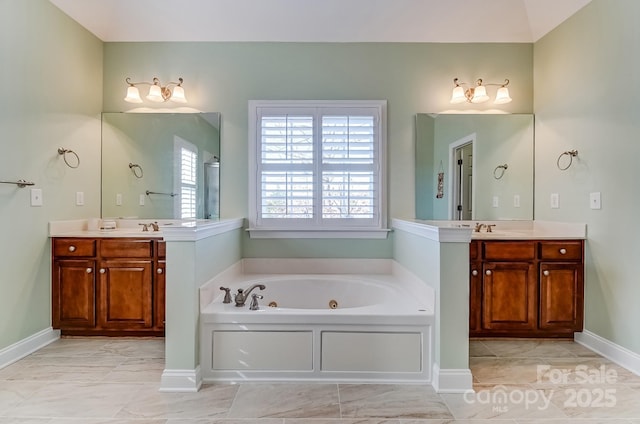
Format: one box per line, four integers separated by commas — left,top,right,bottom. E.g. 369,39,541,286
52,238,164,335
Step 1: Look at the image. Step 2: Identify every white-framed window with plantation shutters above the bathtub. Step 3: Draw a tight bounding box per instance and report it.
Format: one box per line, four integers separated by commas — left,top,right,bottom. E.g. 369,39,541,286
249,101,386,237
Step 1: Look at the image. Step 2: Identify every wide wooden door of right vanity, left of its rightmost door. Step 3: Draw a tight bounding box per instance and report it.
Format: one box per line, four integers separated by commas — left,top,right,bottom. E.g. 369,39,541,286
482,262,538,331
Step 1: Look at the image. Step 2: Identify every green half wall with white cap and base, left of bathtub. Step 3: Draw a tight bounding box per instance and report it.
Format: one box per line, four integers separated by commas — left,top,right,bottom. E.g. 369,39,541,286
160,219,244,392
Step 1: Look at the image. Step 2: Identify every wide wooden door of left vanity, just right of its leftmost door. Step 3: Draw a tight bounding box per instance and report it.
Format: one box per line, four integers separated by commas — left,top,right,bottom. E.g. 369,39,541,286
98,260,153,330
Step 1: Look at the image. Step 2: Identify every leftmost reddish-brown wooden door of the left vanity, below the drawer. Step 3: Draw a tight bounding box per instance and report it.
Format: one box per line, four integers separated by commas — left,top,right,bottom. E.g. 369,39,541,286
52,259,96,329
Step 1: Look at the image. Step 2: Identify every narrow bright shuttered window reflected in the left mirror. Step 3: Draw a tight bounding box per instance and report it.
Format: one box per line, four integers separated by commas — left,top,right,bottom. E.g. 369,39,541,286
174,136,198,219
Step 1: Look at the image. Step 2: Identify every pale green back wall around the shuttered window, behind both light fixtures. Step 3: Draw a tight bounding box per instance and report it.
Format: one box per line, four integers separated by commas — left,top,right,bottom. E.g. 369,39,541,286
104,43,533,257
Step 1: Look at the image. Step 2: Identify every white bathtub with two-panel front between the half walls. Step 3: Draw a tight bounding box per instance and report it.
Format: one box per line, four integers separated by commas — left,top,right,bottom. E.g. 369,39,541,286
200,260,435,383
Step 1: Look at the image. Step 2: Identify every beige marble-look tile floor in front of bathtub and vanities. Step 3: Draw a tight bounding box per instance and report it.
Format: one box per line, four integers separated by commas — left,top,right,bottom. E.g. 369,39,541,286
0,338,640,424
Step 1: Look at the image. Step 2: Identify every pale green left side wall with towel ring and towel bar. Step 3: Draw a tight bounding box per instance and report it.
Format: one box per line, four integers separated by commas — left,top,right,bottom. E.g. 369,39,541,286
0,0,103,350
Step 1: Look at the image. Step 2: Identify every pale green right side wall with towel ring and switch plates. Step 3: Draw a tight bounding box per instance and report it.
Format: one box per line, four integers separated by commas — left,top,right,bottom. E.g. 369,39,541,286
534,0,640,353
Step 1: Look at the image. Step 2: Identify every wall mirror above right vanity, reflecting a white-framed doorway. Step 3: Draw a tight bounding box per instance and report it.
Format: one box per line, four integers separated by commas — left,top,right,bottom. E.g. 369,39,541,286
416,113,534,220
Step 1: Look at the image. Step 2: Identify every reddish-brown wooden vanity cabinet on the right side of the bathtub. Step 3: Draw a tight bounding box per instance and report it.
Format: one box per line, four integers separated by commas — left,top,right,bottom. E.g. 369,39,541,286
469,240,584,337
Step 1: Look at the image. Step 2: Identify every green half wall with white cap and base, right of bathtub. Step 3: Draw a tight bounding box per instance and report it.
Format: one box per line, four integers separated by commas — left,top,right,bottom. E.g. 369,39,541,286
392,219,473,393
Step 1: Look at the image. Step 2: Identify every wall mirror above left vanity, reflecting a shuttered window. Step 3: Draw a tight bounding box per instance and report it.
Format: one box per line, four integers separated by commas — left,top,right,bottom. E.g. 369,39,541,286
102,112,220,219
